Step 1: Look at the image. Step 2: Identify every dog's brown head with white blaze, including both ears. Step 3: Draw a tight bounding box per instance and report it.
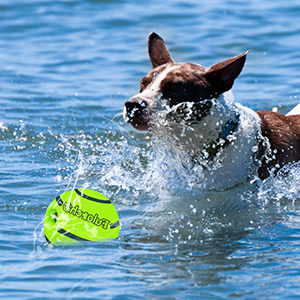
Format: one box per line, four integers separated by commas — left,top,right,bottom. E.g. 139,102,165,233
124,32,249,130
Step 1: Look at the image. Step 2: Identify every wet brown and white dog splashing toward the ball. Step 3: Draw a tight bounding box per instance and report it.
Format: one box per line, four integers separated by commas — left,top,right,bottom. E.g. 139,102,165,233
124,32,300,188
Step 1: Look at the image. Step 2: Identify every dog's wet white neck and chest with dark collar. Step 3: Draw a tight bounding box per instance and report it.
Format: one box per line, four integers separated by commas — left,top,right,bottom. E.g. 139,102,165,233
151,92,260,189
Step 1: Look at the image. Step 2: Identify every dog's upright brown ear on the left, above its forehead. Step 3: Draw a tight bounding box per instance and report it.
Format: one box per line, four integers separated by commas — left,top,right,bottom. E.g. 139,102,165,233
148,32,174,69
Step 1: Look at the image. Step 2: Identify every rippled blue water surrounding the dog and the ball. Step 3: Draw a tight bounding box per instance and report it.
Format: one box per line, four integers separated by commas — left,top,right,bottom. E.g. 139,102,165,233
0,0,300,299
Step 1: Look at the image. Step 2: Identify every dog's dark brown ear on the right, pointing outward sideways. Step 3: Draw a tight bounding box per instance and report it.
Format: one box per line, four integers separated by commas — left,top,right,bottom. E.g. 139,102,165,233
204,50,251,95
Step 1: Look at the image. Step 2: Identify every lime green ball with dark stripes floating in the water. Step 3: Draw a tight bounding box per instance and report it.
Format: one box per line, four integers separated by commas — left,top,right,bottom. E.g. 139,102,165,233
44,189,120,245
